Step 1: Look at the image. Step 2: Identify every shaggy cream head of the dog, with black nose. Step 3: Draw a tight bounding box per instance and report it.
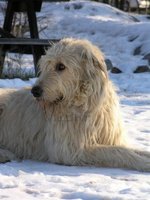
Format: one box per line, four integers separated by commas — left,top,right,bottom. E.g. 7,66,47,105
31,39,108,111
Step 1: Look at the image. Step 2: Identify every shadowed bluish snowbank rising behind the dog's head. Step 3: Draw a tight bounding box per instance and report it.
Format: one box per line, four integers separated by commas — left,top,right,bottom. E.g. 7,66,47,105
38,1,150,72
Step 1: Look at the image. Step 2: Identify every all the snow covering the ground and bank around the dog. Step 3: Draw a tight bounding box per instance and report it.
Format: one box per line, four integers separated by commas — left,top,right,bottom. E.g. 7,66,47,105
0,1,150,200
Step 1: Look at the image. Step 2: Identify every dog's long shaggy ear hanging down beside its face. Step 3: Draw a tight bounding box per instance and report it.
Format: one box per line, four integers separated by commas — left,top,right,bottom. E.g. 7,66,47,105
74,42,108,109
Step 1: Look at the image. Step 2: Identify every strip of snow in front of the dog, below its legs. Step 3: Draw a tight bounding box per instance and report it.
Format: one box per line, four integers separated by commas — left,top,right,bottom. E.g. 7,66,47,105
0,161,150,200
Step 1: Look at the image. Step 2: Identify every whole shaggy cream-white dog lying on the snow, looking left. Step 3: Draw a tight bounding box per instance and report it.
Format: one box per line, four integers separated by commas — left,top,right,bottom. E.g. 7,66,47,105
0,39,150,171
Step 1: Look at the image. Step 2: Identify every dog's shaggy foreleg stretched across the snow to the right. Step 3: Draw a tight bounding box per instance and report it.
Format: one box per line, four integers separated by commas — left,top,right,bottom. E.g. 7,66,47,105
77,146,150,172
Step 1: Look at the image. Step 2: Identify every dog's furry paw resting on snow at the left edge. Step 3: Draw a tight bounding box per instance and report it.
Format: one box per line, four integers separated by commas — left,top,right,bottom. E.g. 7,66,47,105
0,148,16,163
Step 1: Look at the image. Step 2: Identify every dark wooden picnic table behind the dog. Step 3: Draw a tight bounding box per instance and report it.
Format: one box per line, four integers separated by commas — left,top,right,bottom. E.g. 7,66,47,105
0,0,68,76
